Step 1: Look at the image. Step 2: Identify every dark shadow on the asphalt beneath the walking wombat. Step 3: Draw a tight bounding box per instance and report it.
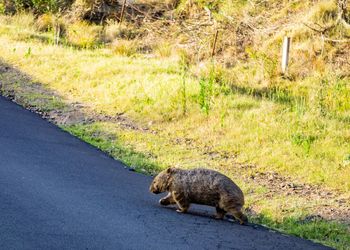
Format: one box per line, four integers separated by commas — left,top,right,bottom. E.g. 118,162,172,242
162,204,268,232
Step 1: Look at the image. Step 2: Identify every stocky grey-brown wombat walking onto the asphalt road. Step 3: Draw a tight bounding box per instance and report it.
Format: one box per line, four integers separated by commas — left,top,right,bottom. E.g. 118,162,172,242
150,168,248,224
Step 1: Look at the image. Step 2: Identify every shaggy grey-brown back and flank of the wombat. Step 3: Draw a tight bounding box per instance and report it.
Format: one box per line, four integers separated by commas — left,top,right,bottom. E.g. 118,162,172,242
173,168,244,206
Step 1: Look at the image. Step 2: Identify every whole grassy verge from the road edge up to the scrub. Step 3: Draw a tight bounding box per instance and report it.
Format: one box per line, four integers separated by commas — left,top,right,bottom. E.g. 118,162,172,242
0,13,350,249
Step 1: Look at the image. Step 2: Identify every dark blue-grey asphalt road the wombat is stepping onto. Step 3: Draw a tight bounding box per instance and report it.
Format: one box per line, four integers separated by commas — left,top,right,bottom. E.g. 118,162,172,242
0,94,326,249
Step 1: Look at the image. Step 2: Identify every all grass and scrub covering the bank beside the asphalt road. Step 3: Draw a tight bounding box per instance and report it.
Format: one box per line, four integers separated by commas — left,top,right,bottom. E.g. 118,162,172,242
0,0,350,249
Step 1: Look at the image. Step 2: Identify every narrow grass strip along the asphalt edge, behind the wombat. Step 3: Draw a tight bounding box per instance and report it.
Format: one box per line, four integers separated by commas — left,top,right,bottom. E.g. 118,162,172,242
63,120,350,249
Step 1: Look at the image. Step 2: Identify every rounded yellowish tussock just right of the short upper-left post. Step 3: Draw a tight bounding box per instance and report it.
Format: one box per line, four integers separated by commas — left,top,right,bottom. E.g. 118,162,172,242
66,21,102,49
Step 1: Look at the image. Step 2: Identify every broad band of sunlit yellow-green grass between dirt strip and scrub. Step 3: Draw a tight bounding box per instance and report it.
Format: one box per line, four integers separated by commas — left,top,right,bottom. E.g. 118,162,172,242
0,12,350,193
